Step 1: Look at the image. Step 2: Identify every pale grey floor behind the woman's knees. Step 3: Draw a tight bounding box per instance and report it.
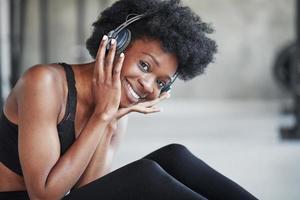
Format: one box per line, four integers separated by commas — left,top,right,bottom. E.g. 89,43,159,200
113,99,300,200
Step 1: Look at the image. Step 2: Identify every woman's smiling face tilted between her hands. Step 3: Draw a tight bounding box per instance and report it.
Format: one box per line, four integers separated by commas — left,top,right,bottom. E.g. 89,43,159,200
120,39,178,107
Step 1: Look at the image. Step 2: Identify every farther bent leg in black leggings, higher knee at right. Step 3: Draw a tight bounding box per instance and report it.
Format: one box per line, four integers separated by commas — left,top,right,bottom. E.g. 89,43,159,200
144,144,257,200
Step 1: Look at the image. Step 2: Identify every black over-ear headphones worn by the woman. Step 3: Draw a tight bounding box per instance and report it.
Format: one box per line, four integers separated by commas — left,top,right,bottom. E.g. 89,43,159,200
106,14,178,93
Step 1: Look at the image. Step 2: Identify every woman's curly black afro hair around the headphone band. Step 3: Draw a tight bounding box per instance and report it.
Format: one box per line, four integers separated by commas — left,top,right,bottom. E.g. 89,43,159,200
86,0,217,81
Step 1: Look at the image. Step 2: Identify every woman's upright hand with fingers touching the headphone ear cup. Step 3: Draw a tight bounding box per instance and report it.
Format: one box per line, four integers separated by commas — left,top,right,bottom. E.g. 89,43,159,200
92,36,124,121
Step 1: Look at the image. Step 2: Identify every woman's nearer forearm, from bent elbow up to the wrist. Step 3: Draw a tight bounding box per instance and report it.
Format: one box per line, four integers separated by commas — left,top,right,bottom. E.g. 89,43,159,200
35,115,108,199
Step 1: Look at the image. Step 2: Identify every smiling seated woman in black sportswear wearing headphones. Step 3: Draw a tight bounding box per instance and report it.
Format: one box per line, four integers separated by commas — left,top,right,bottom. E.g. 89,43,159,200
0,0,256,200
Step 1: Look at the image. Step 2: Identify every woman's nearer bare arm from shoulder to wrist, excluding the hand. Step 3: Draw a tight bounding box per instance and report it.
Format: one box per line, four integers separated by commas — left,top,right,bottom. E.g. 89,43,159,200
16,66,108,200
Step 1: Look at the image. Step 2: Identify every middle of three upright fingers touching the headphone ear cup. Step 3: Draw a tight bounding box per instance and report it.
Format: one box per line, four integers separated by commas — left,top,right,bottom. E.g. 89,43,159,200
104,39,116,82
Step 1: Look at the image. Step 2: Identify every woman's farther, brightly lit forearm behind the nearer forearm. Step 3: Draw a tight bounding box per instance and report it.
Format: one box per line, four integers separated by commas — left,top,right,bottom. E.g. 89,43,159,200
73,116,128,189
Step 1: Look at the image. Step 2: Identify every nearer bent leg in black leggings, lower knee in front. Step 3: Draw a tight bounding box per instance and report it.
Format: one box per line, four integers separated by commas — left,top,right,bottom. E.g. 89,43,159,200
63,159,205,200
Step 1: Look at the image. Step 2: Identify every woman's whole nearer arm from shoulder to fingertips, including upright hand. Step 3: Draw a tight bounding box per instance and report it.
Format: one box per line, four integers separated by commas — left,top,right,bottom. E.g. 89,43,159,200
17,37,124,200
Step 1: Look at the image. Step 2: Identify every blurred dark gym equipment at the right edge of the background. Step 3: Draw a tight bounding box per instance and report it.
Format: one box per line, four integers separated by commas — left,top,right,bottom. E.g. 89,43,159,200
274,0,300,139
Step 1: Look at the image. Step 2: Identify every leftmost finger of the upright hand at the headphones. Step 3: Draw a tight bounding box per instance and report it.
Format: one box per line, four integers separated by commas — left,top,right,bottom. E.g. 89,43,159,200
94,35,108,80
